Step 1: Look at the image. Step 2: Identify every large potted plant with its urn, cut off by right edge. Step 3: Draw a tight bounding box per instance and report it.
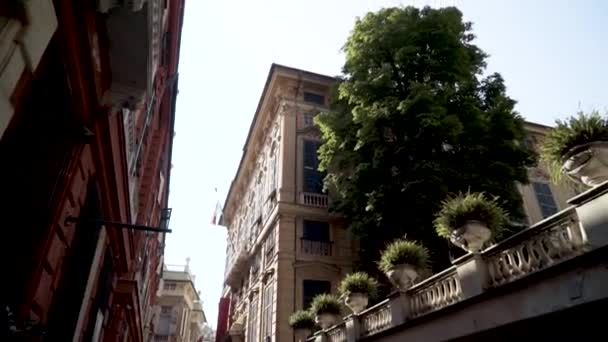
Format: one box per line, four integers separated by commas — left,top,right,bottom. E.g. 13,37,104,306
540,111,608,186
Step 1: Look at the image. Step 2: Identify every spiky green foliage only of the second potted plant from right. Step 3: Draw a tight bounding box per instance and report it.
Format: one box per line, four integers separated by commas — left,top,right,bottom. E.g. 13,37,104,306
434,192,509,239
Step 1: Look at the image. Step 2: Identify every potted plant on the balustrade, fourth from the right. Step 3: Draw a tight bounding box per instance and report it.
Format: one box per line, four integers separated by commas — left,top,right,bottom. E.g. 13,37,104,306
339,272,378,314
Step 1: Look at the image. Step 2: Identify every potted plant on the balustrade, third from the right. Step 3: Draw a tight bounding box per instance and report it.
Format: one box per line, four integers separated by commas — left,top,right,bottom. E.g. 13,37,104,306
378,238,429,291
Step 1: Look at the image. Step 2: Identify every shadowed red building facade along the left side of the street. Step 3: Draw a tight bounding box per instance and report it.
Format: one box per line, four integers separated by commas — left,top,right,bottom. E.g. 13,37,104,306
0,0,184,341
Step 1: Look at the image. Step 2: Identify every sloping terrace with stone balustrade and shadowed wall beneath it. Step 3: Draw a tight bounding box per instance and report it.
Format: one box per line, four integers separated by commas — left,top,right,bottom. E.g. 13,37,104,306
308,182,608,342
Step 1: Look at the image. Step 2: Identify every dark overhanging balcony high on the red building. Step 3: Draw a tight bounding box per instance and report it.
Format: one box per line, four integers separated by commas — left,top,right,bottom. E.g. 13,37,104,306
97,0,163,109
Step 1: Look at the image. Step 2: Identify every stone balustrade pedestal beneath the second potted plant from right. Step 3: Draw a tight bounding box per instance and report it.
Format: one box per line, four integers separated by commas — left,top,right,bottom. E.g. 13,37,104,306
454,253,488,300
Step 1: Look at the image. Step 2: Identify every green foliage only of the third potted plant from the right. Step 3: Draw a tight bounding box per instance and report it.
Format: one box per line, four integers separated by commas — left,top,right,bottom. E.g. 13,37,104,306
378,238,429,273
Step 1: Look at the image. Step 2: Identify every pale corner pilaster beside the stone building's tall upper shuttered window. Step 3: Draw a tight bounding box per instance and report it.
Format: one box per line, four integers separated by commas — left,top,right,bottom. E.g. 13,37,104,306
277,103,299,203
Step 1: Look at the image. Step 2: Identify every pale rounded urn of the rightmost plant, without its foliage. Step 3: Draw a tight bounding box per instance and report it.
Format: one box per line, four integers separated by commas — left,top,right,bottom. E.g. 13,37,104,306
561,141,608,187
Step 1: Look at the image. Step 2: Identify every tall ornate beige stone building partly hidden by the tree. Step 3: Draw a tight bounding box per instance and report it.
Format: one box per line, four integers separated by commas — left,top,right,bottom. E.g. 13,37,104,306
217,64,571,342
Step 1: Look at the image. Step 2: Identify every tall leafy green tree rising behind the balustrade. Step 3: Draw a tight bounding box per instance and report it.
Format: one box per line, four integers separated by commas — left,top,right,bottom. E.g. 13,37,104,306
317,7,535,272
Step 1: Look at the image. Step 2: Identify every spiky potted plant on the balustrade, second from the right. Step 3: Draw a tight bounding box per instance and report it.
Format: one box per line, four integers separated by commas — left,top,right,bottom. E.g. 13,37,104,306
434,192,508,252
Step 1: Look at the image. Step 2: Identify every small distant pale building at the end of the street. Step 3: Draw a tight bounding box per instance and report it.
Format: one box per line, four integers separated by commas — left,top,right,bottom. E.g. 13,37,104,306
148,264,207,342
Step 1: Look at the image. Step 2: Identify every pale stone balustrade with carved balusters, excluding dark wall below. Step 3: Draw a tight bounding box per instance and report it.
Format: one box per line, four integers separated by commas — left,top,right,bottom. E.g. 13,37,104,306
308,182,608,342
